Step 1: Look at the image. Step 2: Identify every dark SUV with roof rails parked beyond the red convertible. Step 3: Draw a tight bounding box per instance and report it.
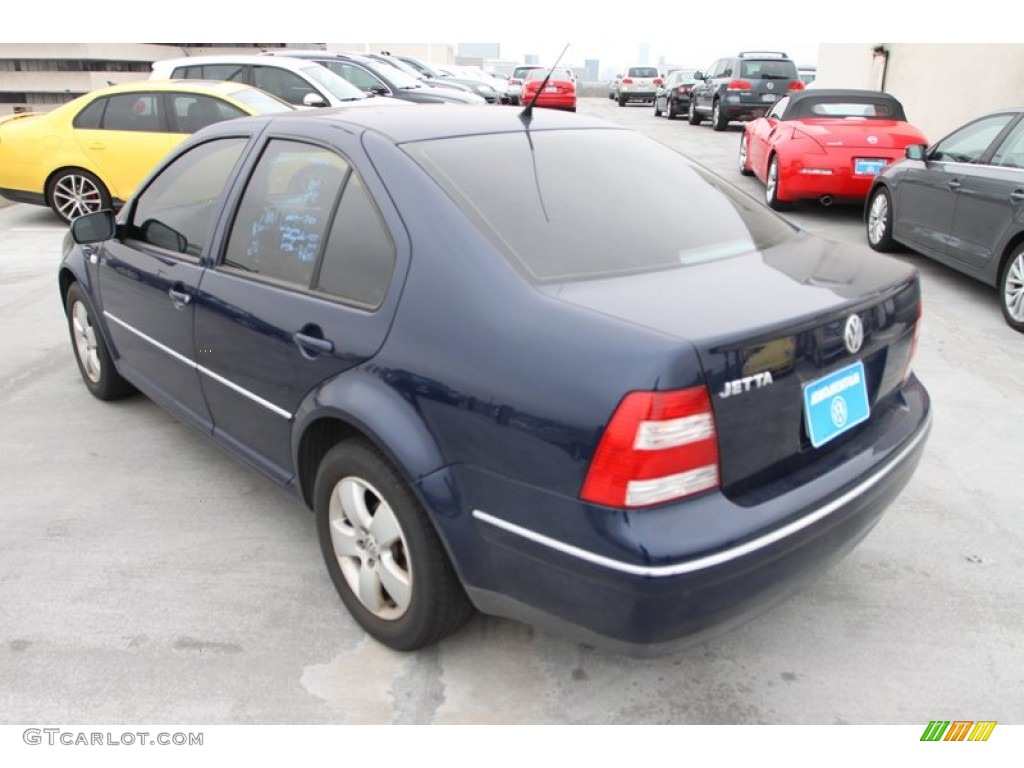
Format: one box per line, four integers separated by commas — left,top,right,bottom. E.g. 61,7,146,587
688,51,804,131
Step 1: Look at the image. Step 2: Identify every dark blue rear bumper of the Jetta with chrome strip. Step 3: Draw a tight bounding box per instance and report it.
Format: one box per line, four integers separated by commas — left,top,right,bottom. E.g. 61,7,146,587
428,380,931,655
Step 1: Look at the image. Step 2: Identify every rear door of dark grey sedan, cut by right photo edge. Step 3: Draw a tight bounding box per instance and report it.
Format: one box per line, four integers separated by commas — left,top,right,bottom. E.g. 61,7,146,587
950,118,1024,274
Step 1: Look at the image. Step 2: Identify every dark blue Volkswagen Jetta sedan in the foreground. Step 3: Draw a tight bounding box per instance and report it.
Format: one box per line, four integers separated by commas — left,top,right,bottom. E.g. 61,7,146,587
59,106,930,653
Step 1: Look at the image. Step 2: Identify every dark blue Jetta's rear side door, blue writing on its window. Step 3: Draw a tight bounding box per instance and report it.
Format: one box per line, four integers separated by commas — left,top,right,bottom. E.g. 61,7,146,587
196,134,396,481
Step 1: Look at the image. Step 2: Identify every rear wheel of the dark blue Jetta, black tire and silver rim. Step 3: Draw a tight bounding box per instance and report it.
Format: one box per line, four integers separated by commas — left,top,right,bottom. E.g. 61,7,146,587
313,439,473,650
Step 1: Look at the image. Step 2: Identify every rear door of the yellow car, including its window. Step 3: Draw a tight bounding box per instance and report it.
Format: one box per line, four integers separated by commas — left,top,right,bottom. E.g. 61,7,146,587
75,91,179,200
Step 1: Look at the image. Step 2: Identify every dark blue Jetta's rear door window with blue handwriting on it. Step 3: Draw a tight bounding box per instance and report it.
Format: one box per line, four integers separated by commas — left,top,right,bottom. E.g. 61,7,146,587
223,139,349,288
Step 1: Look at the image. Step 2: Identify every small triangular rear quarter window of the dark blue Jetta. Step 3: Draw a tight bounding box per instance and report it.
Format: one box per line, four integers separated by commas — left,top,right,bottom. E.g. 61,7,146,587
315,172,395,309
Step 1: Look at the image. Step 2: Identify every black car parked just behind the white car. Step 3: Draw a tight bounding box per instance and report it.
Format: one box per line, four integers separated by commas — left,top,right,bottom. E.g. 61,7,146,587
253,49,486,104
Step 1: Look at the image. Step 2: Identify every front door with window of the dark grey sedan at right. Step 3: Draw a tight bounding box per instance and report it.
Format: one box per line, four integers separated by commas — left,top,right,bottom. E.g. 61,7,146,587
893,115,1013,261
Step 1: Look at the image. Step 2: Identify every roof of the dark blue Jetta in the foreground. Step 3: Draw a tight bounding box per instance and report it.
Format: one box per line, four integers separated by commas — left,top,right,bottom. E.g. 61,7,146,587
207,103,610,143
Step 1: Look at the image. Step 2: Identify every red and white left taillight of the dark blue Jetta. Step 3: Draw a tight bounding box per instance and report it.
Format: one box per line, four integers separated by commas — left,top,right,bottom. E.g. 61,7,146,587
580,387,719,507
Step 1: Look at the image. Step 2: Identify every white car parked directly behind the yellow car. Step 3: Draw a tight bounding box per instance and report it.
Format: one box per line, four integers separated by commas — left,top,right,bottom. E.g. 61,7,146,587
150,54,409,106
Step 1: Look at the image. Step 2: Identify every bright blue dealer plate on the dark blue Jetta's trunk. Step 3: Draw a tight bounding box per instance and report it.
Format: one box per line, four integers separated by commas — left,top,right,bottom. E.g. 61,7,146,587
804,360,871,447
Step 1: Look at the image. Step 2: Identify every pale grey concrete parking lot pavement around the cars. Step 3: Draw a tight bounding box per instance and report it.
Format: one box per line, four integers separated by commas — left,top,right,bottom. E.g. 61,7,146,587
0,98,1024,728
